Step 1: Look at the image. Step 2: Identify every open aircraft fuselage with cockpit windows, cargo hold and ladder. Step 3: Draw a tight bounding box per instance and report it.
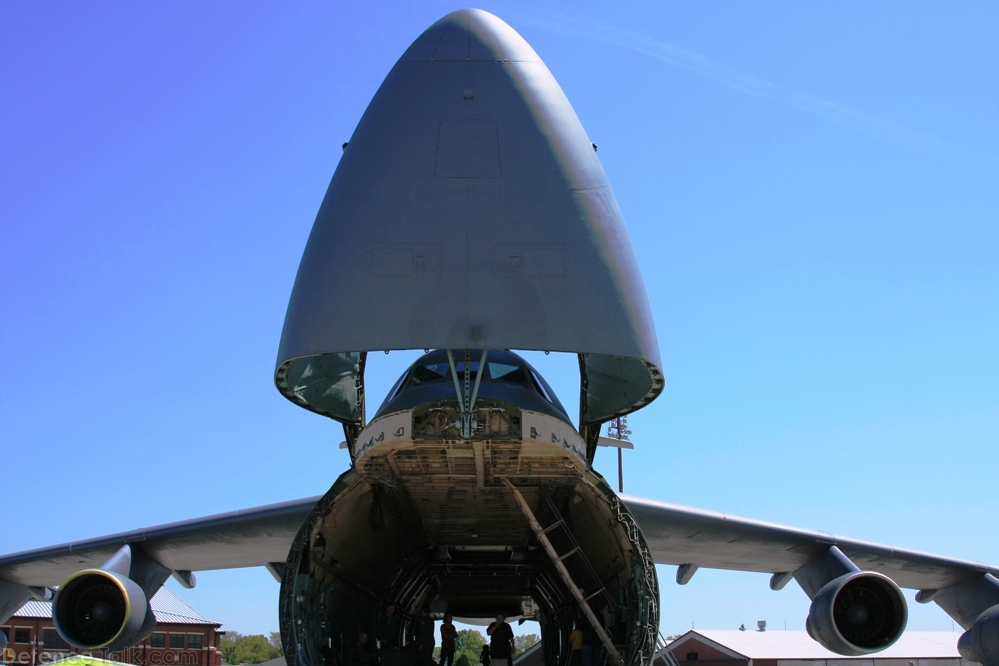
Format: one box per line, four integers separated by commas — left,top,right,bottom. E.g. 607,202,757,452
281,350,658,664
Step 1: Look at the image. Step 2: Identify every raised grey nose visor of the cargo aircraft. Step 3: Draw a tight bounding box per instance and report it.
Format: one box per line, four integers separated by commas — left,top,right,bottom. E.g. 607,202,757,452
276,9,663,434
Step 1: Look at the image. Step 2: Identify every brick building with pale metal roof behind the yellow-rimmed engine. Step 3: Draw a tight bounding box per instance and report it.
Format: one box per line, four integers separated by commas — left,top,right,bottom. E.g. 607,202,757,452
0,587,224,666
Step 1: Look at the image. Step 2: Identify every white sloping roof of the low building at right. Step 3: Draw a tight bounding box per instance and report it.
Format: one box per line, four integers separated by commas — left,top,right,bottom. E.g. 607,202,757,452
670,629,961,660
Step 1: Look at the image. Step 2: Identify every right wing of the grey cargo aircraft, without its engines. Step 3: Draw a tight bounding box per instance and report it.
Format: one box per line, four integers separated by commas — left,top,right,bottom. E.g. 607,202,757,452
622,496,999,590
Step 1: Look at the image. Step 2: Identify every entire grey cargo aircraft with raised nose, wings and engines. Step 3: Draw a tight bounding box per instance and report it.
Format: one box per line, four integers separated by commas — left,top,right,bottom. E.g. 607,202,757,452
0,10,999,666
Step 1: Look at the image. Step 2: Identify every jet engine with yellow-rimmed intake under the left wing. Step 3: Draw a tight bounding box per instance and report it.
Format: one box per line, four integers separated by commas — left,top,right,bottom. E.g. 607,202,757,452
52,569,156,650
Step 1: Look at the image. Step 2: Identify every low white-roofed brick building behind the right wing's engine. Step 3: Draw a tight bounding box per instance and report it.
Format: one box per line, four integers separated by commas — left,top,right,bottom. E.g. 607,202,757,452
654,629,977,666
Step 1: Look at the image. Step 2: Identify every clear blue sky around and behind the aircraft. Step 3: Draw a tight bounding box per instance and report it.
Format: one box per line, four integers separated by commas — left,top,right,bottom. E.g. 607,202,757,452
0,0,999,634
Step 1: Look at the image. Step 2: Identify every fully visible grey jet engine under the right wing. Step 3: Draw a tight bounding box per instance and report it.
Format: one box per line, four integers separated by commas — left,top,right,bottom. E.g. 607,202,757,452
805,571,909,657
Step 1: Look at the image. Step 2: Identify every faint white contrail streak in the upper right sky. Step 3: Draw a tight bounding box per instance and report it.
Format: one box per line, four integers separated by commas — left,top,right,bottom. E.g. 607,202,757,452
527,12,995,159
